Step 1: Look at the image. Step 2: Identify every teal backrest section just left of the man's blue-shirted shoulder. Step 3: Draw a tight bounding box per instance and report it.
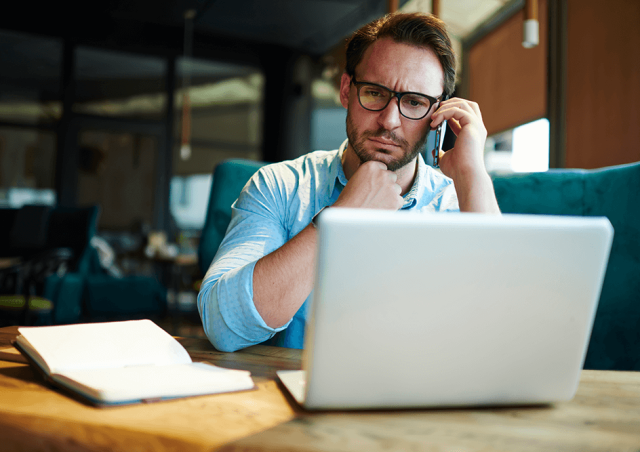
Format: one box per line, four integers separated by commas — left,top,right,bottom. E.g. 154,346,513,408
198,159,266,275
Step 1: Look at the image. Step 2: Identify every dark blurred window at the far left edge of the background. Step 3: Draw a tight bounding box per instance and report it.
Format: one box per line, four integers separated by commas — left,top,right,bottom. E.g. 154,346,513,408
0,30,62,207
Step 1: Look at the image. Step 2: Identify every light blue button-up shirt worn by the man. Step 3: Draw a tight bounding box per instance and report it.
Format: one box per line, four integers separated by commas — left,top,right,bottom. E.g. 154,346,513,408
198,141,459,351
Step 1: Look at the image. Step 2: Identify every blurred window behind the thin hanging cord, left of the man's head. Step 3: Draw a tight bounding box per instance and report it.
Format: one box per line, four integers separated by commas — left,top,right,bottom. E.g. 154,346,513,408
169,58,264,232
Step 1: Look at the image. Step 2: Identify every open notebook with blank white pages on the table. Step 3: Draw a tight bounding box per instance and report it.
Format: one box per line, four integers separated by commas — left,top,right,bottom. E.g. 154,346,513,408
14,320,254,405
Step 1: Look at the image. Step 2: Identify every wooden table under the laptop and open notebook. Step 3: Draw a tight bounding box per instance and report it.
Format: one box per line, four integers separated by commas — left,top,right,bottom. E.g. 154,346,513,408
0,327,640,452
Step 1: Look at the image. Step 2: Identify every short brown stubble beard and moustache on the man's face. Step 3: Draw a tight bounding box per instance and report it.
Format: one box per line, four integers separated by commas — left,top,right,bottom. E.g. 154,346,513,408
347,112,429,171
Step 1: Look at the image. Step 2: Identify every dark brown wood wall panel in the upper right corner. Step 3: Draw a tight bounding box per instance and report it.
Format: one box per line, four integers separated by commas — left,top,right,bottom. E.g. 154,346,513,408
565,0,640,168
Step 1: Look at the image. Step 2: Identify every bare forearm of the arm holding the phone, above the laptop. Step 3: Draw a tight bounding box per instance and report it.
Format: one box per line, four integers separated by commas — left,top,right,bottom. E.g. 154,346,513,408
453,170,500,214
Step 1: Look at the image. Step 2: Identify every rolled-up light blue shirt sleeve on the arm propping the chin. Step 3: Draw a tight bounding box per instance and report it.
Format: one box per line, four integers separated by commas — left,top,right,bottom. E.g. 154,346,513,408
198,168,291,351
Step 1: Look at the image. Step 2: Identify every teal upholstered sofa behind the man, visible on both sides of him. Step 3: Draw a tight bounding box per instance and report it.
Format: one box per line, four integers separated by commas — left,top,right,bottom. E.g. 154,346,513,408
198,160,640,370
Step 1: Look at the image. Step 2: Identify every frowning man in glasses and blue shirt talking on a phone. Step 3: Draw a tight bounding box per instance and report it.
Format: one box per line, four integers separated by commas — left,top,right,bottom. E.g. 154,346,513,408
198,9,499,351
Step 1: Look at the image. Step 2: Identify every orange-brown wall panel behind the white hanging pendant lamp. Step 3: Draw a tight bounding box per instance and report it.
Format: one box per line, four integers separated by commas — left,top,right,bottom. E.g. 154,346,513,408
465,0,548,135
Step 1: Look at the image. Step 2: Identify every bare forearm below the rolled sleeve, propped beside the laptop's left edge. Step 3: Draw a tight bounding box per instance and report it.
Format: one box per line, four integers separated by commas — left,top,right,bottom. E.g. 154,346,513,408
253,225,317,328
